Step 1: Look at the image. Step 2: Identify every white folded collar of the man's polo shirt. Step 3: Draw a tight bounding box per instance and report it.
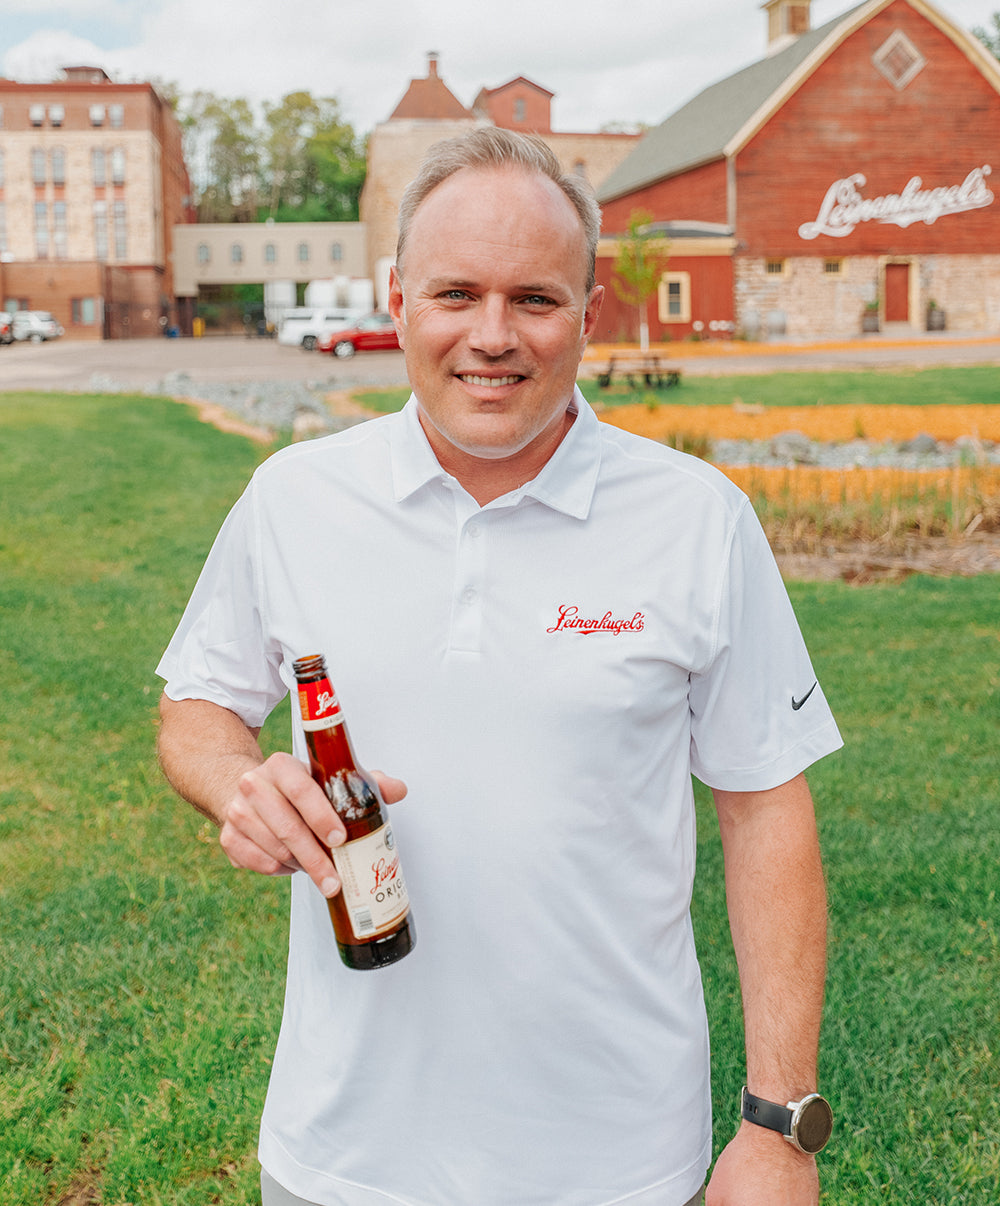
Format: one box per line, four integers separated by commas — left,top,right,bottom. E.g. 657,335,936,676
390,388,601,519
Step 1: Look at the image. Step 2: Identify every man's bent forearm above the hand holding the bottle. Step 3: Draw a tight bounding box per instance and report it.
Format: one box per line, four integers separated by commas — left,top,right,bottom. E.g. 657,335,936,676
157,695,264,826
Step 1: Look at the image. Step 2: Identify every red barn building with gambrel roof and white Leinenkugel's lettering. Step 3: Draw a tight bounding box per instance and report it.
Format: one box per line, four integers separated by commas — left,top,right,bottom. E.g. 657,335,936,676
598,0,1000,340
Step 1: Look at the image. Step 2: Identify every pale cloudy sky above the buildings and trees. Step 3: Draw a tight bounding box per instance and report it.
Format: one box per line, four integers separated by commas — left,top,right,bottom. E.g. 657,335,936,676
0,0,1000,134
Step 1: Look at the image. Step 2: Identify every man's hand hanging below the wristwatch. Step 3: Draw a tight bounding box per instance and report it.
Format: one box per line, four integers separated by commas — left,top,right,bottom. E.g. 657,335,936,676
704,1122,819,1206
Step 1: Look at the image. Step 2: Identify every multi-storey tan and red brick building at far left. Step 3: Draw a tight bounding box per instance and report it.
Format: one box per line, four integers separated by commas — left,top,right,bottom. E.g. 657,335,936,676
0,68,195,339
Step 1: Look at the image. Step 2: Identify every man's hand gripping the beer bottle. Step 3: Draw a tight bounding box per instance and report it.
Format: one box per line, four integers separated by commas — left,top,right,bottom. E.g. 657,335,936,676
218,753,407,896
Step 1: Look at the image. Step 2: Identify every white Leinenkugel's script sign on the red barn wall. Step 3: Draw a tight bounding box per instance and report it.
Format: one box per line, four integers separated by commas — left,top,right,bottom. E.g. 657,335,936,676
799,163,993,239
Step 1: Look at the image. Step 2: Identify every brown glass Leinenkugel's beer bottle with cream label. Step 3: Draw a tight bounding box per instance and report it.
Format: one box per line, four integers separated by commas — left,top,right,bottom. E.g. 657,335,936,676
292,654,416,971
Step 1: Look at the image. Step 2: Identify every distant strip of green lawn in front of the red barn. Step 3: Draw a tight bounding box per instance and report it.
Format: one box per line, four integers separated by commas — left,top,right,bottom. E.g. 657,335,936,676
356,361,998,412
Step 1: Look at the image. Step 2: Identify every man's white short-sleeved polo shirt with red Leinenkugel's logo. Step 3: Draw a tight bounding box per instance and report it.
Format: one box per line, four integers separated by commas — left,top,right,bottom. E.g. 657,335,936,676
159,393,840,1206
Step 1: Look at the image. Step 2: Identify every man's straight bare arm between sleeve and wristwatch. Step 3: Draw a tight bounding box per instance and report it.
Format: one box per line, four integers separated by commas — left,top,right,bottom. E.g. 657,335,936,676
715,775,826,1103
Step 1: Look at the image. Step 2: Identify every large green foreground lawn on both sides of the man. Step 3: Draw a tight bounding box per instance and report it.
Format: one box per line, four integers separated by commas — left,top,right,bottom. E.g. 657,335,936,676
0,390,1000,1206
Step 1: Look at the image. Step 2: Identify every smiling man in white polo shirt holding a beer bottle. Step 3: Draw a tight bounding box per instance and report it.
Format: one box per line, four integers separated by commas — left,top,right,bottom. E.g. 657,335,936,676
160,129,840,1206
